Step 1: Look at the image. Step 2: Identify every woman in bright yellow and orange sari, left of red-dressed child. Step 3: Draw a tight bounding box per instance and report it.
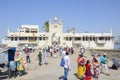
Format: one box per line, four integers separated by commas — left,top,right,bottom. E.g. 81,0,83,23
77,54,85,79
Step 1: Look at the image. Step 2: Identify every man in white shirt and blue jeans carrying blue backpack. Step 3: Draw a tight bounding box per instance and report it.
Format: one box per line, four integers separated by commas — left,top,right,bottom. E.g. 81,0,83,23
64,52,71,80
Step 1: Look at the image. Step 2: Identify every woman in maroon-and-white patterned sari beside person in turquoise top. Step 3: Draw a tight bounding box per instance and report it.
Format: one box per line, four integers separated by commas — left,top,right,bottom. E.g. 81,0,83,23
92,53,100,78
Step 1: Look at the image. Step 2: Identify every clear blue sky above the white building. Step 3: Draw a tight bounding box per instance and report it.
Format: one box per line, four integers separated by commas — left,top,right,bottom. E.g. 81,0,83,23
0,0,120,43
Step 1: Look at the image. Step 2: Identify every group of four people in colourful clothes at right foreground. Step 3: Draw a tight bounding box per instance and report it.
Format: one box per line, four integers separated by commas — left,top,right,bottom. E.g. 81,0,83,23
77,49,110,80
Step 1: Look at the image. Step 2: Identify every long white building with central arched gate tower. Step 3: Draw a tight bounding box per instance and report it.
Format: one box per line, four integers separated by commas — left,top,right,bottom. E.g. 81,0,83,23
2,17,114,50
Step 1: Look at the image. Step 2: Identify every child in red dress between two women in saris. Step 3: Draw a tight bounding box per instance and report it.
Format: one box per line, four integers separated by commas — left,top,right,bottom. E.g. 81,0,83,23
85,60,92,80
